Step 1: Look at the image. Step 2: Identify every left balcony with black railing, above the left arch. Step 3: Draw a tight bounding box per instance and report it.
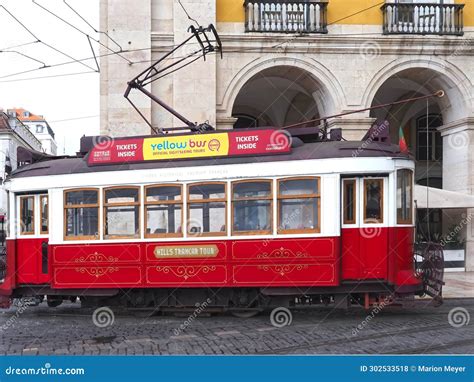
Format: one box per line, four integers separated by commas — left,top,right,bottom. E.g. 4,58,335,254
244,0,328,33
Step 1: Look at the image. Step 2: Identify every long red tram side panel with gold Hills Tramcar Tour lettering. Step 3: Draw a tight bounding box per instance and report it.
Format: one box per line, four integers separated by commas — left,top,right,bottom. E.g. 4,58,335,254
52,237,340,289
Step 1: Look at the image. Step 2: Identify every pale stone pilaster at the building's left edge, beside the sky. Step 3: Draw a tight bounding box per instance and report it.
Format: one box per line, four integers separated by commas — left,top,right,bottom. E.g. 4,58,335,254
100,0,151,136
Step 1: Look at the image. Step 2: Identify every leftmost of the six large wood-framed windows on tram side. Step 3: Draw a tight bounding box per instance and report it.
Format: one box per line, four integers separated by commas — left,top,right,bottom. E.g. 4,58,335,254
64,189,99,240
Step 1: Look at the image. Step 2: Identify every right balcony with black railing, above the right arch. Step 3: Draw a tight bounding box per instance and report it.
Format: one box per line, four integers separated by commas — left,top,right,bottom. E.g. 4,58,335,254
382,3,464,36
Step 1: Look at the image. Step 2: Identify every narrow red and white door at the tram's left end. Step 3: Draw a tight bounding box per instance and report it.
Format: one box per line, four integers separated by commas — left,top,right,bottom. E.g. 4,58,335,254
15,194,49,284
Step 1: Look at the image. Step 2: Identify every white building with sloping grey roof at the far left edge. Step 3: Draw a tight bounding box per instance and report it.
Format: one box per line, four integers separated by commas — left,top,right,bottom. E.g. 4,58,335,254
0,109,42,237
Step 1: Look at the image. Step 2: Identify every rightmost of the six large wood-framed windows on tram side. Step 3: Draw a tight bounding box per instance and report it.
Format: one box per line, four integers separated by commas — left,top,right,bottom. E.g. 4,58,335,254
278,178,320,233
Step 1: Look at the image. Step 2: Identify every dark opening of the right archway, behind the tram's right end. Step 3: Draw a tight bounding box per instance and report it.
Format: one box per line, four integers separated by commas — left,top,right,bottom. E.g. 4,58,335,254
370,68,465,240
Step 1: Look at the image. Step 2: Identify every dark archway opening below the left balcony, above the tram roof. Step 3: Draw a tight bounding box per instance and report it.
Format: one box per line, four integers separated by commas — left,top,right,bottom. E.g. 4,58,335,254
232,65,328,128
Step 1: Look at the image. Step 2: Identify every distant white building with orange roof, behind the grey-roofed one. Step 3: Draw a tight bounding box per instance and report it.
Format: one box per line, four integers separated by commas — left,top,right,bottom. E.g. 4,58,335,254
8,108,58,155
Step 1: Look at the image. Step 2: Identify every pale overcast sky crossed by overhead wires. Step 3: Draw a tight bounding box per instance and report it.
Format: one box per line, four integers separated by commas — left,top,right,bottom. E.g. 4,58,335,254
0,0,100,154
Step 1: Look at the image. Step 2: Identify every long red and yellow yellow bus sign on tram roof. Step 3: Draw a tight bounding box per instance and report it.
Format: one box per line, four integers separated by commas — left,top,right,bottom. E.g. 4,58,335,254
87,129,291,166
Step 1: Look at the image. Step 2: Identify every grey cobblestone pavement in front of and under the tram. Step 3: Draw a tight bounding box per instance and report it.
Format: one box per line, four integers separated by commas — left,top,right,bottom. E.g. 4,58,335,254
0,299,474,355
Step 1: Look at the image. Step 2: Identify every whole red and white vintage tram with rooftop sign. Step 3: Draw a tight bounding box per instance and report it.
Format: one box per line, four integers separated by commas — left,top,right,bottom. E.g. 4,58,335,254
0,129,436,312
